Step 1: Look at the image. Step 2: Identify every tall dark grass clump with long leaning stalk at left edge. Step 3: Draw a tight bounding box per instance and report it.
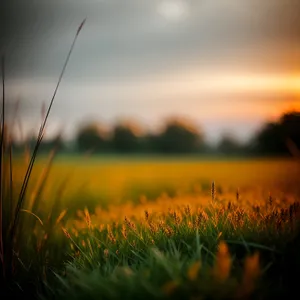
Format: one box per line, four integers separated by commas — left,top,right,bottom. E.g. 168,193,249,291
0,20,85,297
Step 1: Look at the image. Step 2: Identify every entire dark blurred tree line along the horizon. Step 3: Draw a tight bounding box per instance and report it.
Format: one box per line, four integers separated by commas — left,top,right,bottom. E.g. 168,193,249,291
10,111,300,156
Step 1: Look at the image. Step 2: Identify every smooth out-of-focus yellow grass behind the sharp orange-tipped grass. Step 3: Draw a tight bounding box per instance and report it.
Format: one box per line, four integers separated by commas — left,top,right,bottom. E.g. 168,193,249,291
10,156,297,210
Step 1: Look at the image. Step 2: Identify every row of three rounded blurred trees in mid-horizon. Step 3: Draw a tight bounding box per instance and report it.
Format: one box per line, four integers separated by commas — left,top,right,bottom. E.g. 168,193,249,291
76,119,204,154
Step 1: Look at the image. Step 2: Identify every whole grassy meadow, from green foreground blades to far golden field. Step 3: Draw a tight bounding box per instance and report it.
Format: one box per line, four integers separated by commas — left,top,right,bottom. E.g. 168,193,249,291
4,155,300,299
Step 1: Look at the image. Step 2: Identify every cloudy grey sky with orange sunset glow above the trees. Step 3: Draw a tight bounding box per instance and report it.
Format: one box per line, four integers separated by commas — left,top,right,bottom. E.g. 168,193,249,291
0,0,300,142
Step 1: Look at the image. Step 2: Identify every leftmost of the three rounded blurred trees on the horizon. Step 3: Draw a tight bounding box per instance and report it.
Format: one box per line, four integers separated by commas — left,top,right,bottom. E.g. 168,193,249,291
76,123,108,152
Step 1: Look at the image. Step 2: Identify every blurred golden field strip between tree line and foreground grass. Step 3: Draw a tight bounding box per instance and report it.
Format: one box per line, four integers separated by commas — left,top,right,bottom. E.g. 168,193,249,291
10,156,299,222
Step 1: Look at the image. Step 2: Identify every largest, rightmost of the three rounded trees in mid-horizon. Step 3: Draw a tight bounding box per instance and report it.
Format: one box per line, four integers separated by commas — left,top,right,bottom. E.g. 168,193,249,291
152,119,204,153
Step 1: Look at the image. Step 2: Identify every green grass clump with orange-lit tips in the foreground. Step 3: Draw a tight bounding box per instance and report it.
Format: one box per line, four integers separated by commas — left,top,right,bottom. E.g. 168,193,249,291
44,199,300,299
